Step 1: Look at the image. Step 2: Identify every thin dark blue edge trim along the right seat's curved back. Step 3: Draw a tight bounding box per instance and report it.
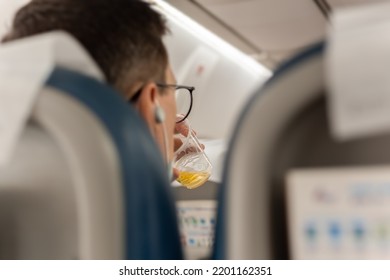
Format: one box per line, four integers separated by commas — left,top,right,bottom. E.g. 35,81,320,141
212,43,325,259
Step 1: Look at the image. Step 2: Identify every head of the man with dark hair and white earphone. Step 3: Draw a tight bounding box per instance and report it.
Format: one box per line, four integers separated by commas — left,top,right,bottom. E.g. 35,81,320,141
3,0,187,174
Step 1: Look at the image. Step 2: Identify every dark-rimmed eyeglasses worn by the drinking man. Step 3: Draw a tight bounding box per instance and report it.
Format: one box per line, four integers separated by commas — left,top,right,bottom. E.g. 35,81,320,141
156,83,195,123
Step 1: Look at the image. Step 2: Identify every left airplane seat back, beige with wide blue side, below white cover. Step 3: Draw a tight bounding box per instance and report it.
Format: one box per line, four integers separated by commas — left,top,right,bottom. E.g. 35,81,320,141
0,41,182,259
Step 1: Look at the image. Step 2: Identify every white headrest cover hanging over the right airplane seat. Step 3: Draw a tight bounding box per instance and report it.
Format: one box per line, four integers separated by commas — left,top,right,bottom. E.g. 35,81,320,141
326,3,390,140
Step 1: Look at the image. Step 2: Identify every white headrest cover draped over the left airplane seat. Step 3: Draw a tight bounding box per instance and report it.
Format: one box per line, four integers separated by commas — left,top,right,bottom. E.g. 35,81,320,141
0,32,103,166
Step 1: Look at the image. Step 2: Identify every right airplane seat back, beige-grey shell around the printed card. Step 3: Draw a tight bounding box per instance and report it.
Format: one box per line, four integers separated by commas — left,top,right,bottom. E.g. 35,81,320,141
213,44,390,259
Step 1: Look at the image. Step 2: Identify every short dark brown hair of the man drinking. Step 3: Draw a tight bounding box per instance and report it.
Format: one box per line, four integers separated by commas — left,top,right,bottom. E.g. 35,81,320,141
2,0,168,96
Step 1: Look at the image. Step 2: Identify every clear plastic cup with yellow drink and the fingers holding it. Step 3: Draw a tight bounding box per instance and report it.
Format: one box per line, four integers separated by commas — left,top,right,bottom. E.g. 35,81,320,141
173,121,212,189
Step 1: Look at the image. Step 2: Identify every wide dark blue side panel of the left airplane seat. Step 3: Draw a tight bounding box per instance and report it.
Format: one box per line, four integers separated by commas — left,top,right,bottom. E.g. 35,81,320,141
46,68,182,259
